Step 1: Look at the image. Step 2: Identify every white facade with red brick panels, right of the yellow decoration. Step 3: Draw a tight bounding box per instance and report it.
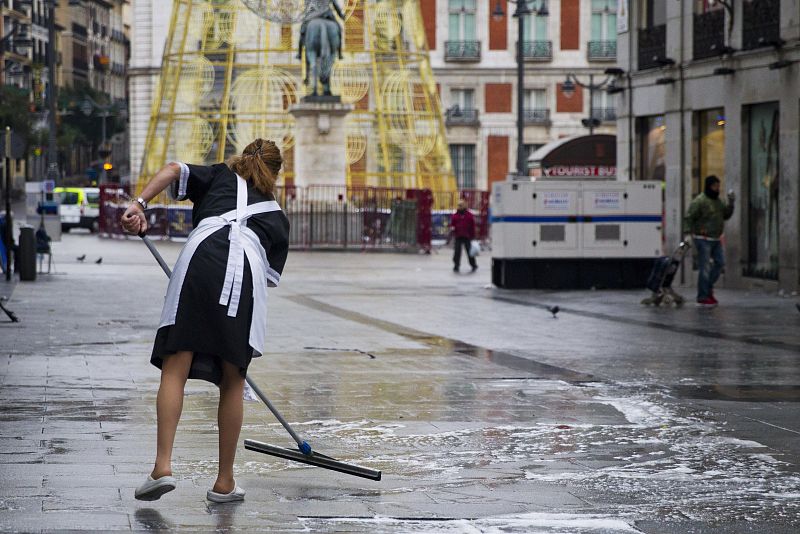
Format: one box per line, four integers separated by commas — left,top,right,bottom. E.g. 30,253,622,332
420,0,617,193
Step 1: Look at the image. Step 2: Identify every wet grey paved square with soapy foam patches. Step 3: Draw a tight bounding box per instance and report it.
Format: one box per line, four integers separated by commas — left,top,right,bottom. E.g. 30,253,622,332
0,234,800,533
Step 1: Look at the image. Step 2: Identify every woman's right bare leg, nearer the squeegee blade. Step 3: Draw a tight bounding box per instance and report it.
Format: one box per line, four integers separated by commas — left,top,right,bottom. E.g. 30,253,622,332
214,361,244,493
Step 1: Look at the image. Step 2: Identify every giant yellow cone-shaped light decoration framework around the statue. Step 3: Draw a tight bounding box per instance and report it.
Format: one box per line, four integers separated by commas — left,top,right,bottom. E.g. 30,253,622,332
137,0,456,197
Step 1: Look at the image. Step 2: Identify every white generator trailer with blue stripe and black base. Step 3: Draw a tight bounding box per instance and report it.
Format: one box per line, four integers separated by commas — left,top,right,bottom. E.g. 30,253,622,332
490,180,663,289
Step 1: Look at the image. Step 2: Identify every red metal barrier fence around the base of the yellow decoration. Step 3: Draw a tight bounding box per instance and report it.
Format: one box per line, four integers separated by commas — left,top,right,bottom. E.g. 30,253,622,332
100,184,489,251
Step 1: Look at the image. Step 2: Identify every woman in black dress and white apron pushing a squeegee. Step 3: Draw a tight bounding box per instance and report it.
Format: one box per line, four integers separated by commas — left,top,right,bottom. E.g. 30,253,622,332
122,139,289,502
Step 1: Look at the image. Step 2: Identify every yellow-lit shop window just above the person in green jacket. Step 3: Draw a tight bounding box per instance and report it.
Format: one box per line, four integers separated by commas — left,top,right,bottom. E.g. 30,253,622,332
692,108,725,197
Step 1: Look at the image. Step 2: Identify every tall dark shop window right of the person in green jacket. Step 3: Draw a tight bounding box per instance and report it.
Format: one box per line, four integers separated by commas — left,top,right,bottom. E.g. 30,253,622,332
744,102,780,280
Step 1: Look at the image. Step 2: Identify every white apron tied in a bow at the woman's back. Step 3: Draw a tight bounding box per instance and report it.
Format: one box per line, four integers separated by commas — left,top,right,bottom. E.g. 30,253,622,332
158,174,281,356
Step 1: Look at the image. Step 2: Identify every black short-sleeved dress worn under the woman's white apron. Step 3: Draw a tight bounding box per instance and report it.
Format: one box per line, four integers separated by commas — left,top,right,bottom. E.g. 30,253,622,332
150,163,289,385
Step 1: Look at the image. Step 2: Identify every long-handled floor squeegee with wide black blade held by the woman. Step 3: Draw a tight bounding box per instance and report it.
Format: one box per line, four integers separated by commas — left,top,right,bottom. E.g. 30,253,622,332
139,234,381,480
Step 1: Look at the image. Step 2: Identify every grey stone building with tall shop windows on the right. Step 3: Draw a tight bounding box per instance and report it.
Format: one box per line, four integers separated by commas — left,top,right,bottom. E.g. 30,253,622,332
617,0,800,291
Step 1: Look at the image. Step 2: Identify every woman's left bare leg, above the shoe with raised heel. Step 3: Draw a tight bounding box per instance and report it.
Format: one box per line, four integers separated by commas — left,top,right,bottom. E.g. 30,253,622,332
150,351,194,479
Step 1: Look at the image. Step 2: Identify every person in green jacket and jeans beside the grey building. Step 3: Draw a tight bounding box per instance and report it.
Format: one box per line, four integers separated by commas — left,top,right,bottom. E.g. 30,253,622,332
686,175,735,307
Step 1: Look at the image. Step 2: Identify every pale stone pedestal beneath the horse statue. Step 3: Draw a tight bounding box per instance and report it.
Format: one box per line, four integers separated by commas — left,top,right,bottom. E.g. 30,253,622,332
289,100,353,186
